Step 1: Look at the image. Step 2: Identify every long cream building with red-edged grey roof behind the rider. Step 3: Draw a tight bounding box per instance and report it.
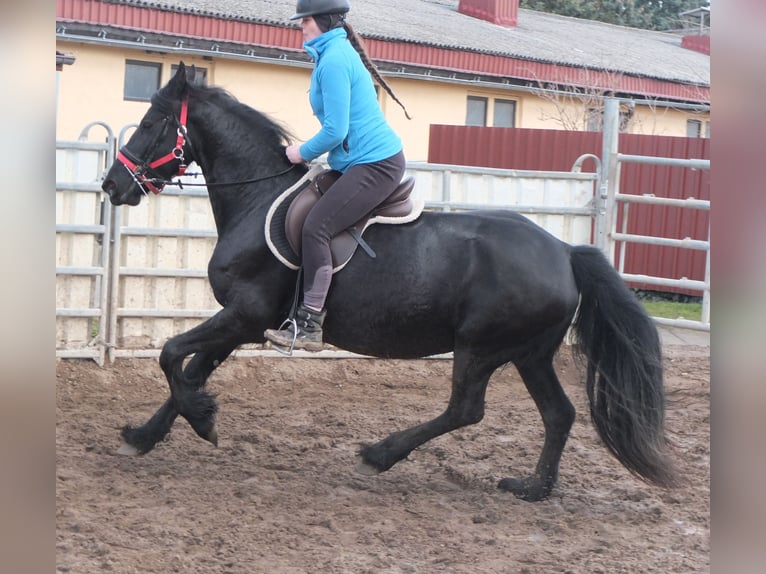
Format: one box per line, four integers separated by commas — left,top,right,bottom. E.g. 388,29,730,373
56,0,710,160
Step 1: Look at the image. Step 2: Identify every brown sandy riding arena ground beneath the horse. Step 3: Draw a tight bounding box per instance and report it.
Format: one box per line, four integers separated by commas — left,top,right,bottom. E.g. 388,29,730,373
56,346,710,574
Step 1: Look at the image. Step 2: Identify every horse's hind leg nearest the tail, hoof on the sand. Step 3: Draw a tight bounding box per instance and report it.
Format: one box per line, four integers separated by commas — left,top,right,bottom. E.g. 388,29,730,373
498,357,575,501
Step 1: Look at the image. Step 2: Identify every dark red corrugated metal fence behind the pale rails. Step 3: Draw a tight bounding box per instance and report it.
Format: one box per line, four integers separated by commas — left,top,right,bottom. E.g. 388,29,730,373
428,112,711,296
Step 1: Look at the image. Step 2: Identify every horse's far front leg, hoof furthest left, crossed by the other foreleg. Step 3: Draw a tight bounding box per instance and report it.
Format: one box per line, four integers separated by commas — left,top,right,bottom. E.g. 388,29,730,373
118,349,233,455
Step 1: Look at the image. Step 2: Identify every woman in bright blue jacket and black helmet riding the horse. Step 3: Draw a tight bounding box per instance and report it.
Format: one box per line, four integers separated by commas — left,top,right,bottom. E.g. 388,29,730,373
264,0,409,351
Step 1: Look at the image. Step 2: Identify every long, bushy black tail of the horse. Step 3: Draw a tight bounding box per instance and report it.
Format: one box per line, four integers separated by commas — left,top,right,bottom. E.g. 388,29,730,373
571,245,675,486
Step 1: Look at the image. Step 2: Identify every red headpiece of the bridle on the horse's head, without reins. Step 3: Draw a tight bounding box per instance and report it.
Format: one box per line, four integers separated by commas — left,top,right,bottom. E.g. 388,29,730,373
117,98,189,195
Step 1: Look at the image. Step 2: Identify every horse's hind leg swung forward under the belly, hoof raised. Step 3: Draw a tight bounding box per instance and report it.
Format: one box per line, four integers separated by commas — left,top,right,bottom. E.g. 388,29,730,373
357,350,499,474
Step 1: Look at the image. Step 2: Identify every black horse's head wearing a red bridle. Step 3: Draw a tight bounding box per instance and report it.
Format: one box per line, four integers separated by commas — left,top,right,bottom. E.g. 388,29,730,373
101,62,194,205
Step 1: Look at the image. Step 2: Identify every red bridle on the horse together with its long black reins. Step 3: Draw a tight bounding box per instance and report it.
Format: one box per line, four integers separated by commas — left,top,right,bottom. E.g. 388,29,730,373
117,97,299,195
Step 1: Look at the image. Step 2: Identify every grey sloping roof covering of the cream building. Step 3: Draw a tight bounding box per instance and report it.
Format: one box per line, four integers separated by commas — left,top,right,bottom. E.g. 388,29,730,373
106,0,710,86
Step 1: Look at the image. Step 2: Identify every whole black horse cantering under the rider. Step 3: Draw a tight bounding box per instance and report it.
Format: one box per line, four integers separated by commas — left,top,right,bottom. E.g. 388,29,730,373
103,64,675,500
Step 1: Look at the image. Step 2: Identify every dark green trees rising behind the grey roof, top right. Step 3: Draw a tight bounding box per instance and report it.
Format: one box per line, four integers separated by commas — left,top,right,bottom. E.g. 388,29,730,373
519,0,710,30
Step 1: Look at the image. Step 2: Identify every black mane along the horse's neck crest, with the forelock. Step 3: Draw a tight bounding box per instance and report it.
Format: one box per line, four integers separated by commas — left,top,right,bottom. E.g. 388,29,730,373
152,84,294,145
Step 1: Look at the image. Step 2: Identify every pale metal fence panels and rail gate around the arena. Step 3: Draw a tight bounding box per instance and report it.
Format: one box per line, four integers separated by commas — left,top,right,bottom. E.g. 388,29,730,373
56,102,710,364
